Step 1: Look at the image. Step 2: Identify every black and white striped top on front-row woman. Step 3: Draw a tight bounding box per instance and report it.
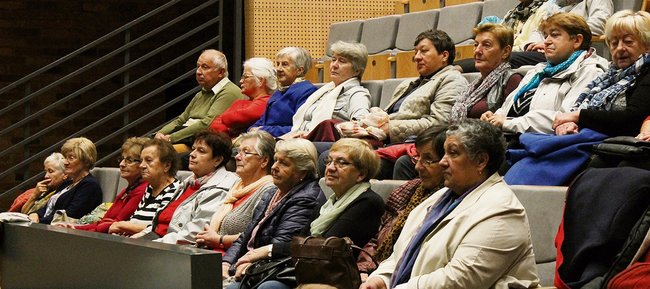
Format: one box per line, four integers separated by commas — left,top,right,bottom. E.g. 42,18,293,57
131,179,183,224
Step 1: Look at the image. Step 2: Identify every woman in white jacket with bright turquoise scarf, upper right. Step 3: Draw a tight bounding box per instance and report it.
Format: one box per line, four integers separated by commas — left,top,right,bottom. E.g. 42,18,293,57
481,13,607,133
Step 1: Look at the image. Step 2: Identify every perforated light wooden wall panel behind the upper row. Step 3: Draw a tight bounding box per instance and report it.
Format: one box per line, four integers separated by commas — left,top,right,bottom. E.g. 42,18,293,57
244,0,395,59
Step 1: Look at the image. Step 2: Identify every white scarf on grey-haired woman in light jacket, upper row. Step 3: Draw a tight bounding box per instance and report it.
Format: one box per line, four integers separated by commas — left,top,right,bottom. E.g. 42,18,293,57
291,77,358,132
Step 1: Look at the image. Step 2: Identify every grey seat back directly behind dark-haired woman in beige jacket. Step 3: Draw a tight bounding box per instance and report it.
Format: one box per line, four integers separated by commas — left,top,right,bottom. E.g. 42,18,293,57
395,9,440,51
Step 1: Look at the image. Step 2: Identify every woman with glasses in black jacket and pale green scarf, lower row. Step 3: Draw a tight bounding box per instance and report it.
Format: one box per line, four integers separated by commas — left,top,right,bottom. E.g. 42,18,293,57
228,138,384,289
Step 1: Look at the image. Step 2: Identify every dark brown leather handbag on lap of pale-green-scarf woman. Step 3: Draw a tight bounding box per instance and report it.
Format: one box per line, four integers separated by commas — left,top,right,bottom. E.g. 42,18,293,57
291,236,361,288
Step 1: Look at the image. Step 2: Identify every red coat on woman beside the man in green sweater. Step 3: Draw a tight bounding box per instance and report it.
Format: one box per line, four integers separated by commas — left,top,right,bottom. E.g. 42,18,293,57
210,95,271,138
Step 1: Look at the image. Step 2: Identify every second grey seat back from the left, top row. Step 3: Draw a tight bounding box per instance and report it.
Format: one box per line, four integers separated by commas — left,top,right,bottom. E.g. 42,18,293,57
360,15,400,54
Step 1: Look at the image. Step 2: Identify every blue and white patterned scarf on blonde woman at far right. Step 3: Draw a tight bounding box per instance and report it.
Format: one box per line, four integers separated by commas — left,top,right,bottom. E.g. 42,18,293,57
571,53,650,111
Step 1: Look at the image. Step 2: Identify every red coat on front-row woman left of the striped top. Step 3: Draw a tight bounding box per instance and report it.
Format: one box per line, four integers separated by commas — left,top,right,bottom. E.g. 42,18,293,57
75,182,147,233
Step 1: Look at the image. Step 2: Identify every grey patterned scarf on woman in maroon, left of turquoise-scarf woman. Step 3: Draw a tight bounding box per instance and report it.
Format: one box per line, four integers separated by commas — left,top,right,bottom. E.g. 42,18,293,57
450,62,510,123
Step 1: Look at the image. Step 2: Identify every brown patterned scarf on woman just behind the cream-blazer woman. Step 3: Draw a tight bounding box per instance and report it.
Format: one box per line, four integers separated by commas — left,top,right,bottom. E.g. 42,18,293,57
373,185,442,263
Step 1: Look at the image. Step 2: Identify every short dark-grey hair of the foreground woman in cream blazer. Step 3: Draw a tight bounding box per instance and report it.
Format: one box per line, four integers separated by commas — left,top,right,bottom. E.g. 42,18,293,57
447,118,506,175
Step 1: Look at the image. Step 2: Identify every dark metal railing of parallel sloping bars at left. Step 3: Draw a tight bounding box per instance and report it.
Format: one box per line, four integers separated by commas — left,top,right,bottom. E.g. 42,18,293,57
0,0,223,198
